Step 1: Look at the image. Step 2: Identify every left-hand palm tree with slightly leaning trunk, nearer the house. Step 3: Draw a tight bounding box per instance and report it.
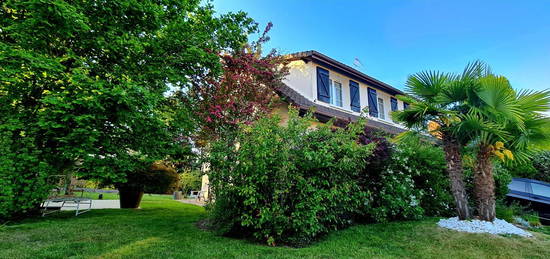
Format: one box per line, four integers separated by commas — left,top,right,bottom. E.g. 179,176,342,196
392,68,471,220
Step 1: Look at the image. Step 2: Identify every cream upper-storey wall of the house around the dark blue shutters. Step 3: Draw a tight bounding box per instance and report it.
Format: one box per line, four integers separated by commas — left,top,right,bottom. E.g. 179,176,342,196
284,60,403,128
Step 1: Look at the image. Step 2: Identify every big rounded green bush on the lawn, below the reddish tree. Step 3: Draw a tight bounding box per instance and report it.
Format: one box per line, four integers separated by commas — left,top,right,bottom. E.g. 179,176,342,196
208,110,373,246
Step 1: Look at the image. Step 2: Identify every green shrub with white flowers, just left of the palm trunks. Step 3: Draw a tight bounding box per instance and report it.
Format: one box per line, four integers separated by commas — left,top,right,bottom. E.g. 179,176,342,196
363,135,452,222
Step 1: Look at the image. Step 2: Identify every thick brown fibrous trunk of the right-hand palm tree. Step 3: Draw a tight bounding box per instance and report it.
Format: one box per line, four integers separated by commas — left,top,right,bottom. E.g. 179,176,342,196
474,145,496,221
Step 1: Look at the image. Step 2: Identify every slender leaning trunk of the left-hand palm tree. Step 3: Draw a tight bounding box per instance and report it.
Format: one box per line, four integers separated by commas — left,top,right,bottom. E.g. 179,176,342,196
443,135,470,220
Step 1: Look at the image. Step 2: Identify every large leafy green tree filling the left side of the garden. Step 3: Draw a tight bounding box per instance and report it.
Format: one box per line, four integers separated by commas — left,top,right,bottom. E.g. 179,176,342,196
0,0,256,221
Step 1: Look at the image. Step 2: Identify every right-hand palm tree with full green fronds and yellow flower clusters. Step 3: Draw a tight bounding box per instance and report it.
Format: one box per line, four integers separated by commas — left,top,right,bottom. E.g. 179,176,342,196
452,74,550,221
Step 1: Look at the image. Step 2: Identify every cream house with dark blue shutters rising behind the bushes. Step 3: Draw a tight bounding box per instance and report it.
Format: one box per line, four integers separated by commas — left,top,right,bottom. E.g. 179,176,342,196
275,50,408,134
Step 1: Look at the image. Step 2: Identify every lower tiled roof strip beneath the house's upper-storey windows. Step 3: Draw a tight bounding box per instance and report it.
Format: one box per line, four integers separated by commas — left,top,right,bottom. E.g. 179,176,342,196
277,84,405,134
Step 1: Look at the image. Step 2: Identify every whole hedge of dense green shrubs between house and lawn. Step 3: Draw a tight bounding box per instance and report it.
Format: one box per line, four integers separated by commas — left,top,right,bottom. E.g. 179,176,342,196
207,111,452,246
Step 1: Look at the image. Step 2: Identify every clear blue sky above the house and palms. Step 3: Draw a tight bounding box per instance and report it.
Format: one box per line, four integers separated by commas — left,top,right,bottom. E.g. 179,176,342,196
213,0,550,94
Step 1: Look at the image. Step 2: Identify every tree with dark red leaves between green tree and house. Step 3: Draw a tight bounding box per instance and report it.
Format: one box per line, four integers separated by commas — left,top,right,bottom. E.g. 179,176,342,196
191,23,288,140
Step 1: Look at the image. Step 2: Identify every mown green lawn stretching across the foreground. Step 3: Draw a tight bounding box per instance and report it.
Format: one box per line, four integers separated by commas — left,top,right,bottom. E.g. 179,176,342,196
0,198,550,258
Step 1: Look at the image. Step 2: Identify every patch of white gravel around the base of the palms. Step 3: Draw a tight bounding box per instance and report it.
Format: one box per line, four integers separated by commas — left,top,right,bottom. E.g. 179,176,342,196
437,217,533,237
